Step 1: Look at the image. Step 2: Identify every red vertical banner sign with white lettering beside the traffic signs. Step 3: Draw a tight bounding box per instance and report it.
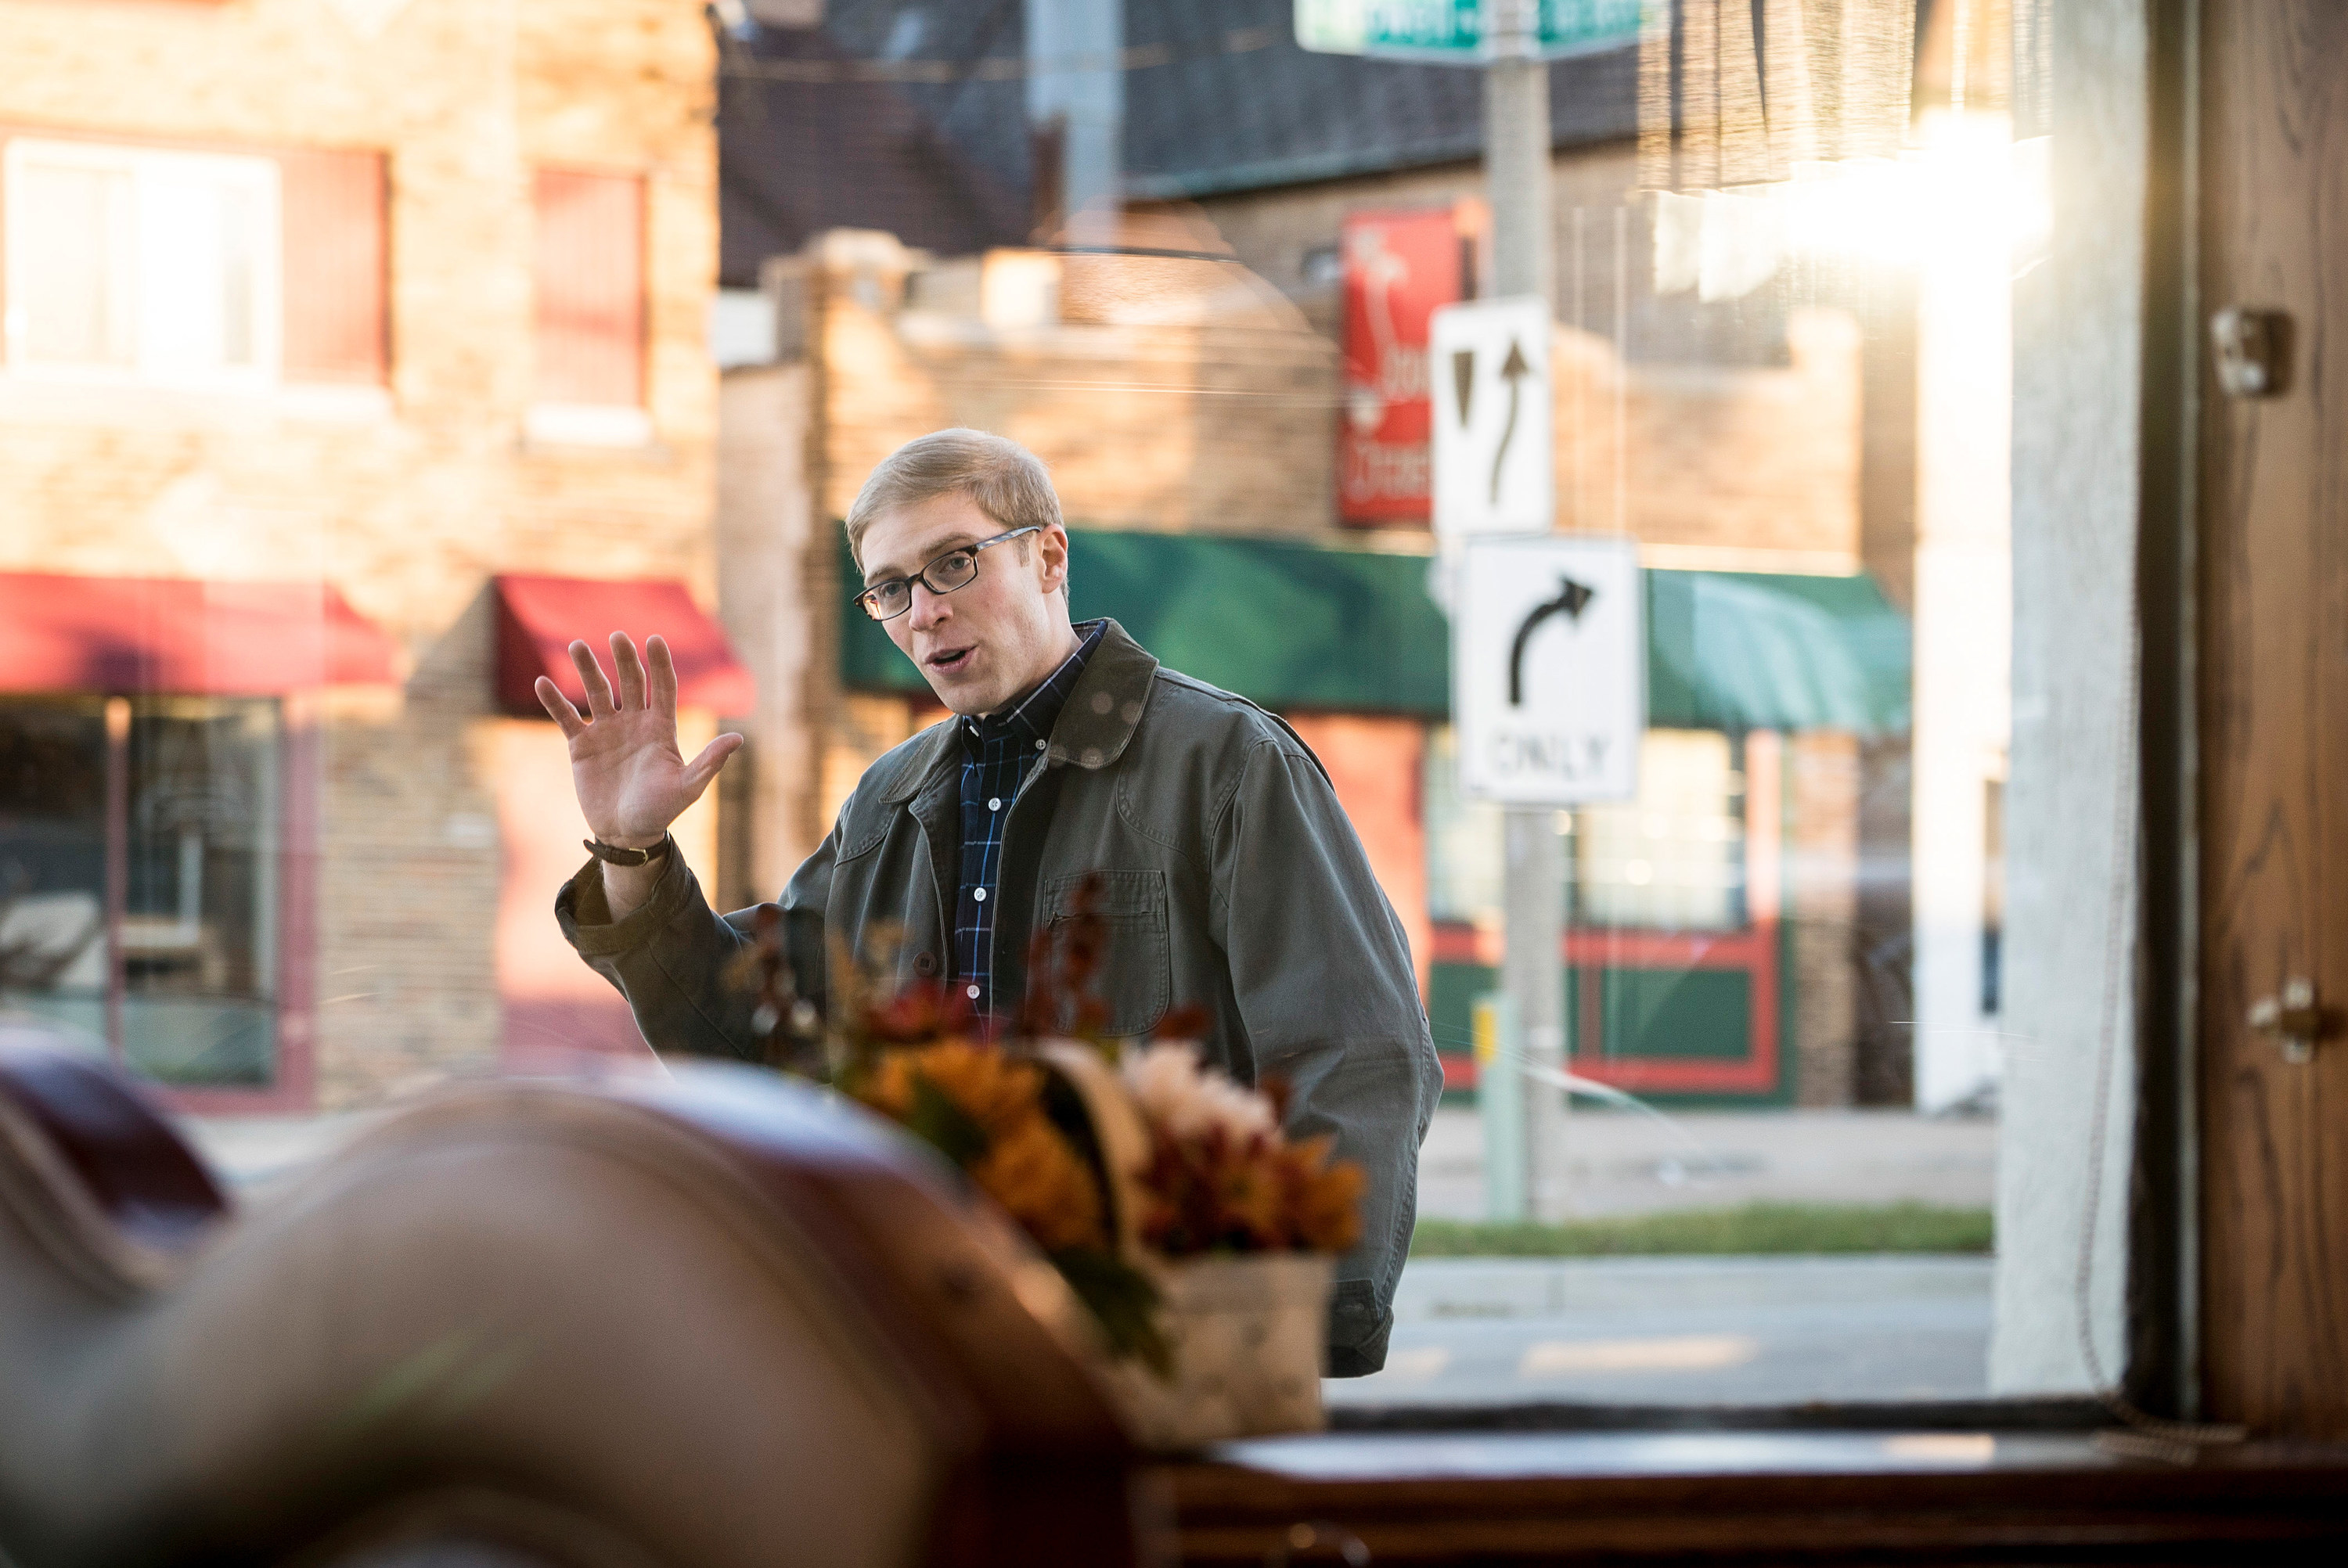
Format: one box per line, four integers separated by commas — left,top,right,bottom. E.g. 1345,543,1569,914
1336,207,1468,528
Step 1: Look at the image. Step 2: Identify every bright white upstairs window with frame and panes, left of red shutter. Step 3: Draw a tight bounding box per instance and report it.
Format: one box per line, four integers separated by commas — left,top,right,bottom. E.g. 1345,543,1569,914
0,136,282,387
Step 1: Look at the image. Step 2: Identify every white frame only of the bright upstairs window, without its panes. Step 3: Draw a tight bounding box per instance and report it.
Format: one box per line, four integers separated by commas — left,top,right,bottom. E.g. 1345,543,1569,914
0,136,284,392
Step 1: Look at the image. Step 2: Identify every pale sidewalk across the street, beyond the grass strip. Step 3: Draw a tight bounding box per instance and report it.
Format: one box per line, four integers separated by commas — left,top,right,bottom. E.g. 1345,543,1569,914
1418,1106,1998,1221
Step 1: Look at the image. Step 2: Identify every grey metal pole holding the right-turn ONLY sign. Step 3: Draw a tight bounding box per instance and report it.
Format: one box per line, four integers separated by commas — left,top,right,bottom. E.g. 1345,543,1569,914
1479,0,1566,1221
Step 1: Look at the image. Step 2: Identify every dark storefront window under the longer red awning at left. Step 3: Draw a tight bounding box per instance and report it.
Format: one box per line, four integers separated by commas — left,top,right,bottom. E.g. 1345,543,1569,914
0,697,282,1087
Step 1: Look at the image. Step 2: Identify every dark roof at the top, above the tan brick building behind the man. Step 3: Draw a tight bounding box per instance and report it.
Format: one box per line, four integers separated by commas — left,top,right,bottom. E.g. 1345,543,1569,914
718,0,1639,286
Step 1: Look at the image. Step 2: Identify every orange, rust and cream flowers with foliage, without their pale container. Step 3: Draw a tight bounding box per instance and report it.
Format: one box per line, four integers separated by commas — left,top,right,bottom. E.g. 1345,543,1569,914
744,890,1364,1411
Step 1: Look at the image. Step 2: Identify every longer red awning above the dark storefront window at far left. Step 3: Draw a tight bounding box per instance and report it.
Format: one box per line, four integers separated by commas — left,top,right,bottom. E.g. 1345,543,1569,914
0,573,397,697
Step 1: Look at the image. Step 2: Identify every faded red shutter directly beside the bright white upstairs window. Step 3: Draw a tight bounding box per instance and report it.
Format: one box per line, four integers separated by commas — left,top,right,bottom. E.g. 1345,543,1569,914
277,150,390,385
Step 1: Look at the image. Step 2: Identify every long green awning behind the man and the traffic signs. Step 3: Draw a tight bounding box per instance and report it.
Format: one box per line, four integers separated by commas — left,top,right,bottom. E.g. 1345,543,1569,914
841,528,1909,735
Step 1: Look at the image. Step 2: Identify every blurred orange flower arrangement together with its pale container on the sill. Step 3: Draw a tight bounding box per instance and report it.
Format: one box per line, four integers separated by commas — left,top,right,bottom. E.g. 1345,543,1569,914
784,878,1364,1451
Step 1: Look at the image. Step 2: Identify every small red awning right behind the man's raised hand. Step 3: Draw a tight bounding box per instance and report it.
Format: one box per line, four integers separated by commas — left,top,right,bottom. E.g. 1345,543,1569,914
493,577,758,718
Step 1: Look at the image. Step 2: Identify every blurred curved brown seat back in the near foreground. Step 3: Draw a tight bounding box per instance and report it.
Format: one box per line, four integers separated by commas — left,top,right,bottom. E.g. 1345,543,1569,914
0,1030,1136,1566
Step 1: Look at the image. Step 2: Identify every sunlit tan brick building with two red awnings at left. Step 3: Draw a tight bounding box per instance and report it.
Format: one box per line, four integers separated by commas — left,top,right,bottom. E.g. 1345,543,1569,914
0,0,749,1110
